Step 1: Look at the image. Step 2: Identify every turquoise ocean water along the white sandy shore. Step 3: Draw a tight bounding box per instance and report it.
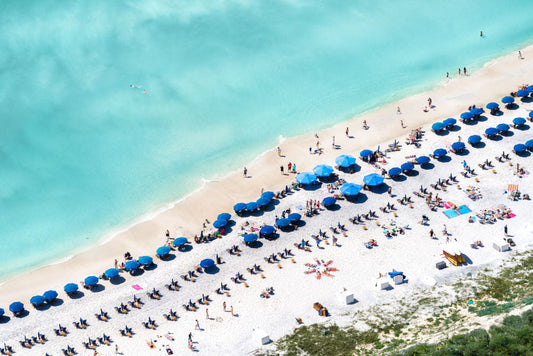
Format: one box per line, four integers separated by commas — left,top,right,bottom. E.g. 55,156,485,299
0,0,533,279
